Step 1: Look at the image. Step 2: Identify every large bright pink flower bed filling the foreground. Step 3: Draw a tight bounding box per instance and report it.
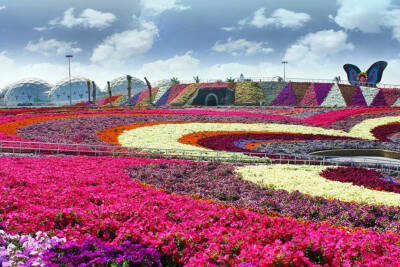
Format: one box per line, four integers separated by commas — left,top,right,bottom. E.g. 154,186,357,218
0,156,400,266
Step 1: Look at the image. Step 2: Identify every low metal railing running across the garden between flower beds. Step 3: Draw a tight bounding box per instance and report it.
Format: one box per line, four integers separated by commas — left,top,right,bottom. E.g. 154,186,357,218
0,140,400,176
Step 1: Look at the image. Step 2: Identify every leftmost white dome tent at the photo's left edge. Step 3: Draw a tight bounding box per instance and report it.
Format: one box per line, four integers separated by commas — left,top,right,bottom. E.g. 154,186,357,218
2,78,52,106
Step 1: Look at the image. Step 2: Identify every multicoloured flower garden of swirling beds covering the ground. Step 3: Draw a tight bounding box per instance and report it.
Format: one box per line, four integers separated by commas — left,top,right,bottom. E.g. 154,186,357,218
0,105,400,267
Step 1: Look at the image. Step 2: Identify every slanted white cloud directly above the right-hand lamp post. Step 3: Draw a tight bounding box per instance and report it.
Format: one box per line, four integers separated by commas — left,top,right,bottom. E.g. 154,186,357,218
284,30,354,62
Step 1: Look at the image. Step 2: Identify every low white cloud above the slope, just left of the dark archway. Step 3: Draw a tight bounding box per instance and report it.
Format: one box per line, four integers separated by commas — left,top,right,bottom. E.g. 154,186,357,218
139,51,200,80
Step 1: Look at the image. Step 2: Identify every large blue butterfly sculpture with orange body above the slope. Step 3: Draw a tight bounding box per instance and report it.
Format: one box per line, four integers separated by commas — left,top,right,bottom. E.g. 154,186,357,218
343,61,387,87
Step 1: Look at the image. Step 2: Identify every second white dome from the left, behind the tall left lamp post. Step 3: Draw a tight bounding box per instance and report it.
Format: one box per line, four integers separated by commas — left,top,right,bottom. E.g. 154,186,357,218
49,77,99,106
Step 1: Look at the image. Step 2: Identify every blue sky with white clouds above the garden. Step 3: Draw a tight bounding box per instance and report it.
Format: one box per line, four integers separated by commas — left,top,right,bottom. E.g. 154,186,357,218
0,0,400,87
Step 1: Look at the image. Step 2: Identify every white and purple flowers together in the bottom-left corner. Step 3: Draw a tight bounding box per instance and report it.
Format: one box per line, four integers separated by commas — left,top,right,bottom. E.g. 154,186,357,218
0,230,162,267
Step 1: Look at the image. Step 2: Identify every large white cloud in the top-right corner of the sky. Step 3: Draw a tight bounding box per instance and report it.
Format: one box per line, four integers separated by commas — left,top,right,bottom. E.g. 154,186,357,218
329,0,400,42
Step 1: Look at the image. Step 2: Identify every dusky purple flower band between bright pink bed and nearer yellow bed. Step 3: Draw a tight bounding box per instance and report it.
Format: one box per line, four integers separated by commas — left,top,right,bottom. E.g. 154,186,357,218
130,163,400,233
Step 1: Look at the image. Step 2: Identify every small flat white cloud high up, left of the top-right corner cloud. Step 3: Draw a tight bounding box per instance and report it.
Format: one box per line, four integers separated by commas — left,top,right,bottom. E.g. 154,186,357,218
238,8,311,29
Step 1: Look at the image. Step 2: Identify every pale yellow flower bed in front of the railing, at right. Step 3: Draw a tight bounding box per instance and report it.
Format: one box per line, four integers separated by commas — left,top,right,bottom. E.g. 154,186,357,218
237,164,400,206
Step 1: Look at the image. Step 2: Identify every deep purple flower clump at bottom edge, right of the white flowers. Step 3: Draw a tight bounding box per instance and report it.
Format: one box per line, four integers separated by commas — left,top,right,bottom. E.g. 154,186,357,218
43,237,162,267
